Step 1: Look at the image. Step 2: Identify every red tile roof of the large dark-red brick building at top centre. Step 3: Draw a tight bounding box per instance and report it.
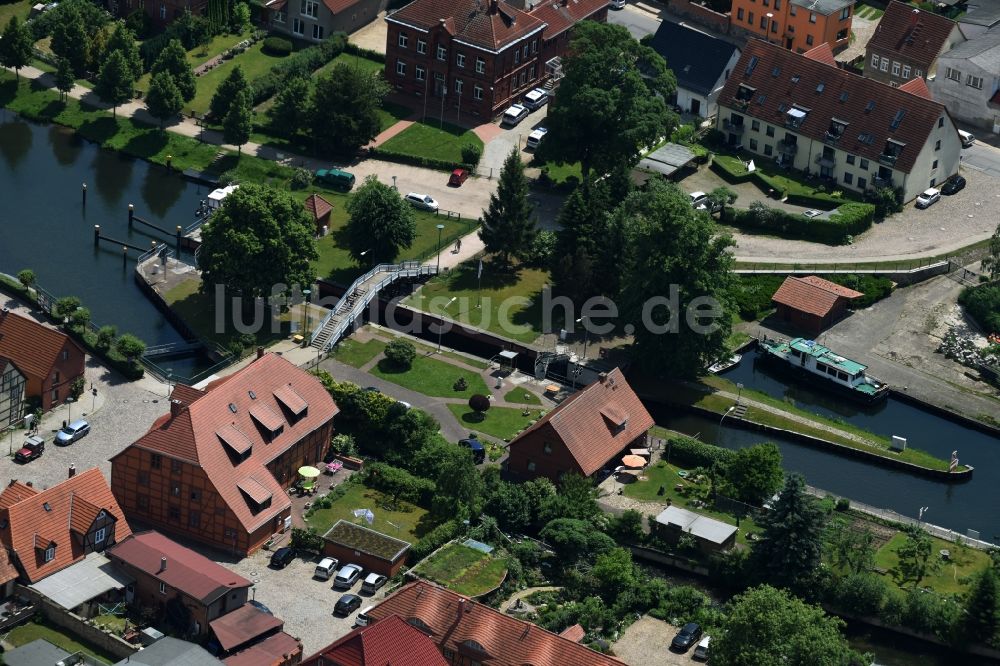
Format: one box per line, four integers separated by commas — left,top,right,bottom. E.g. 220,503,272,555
386,0,545,51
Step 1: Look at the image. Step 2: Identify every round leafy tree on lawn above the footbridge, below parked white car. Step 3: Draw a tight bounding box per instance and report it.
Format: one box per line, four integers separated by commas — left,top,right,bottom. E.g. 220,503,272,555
347,175,417,265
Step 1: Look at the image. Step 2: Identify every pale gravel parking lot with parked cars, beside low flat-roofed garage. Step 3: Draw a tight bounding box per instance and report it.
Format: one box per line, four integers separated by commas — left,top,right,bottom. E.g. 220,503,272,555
216,550,388,656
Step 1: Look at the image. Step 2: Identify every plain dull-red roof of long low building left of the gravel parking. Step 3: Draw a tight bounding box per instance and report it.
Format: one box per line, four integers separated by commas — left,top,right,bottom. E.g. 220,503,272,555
108,532,251,605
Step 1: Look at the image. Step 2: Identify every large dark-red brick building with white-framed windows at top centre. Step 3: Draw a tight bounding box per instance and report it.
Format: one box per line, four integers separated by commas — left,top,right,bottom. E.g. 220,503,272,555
385,0,608,118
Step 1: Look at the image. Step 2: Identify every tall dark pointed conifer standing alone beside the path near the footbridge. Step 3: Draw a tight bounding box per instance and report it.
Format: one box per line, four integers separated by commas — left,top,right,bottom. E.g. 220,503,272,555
479,149,538,267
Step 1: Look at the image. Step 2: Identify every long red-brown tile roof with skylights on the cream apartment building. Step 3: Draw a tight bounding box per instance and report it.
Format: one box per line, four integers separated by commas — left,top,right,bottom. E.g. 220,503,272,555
719,39,958,173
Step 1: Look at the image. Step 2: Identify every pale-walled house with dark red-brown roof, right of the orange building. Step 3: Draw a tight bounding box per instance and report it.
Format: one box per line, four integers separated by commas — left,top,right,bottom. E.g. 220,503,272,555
865,0,965,87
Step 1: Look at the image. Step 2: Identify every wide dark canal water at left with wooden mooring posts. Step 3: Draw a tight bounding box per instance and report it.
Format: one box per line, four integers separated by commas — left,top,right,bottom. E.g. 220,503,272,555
0,120,207,374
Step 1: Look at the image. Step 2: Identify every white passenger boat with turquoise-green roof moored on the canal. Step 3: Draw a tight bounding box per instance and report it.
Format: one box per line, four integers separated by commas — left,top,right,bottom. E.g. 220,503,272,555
757,337,889,403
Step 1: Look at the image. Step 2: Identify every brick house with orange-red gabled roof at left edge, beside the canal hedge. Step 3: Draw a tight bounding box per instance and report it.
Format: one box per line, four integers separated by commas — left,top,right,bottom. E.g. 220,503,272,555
0,308,86,425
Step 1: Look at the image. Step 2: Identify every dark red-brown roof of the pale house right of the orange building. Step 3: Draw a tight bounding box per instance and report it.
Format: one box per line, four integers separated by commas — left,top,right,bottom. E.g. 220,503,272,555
866,0,957,72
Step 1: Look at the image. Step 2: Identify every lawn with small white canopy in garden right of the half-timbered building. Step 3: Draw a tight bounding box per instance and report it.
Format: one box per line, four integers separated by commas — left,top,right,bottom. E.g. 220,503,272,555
306,483,435,543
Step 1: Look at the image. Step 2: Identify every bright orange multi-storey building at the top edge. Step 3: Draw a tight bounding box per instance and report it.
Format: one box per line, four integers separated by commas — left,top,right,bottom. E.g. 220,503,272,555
731,0,854,53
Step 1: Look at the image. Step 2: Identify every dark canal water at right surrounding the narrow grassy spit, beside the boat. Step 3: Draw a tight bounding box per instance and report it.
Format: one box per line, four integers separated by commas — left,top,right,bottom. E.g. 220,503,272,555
657,351,1000,541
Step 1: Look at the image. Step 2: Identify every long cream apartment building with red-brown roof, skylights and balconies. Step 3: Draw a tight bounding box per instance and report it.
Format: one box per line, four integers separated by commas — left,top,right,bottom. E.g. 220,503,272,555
716,40,962,201
